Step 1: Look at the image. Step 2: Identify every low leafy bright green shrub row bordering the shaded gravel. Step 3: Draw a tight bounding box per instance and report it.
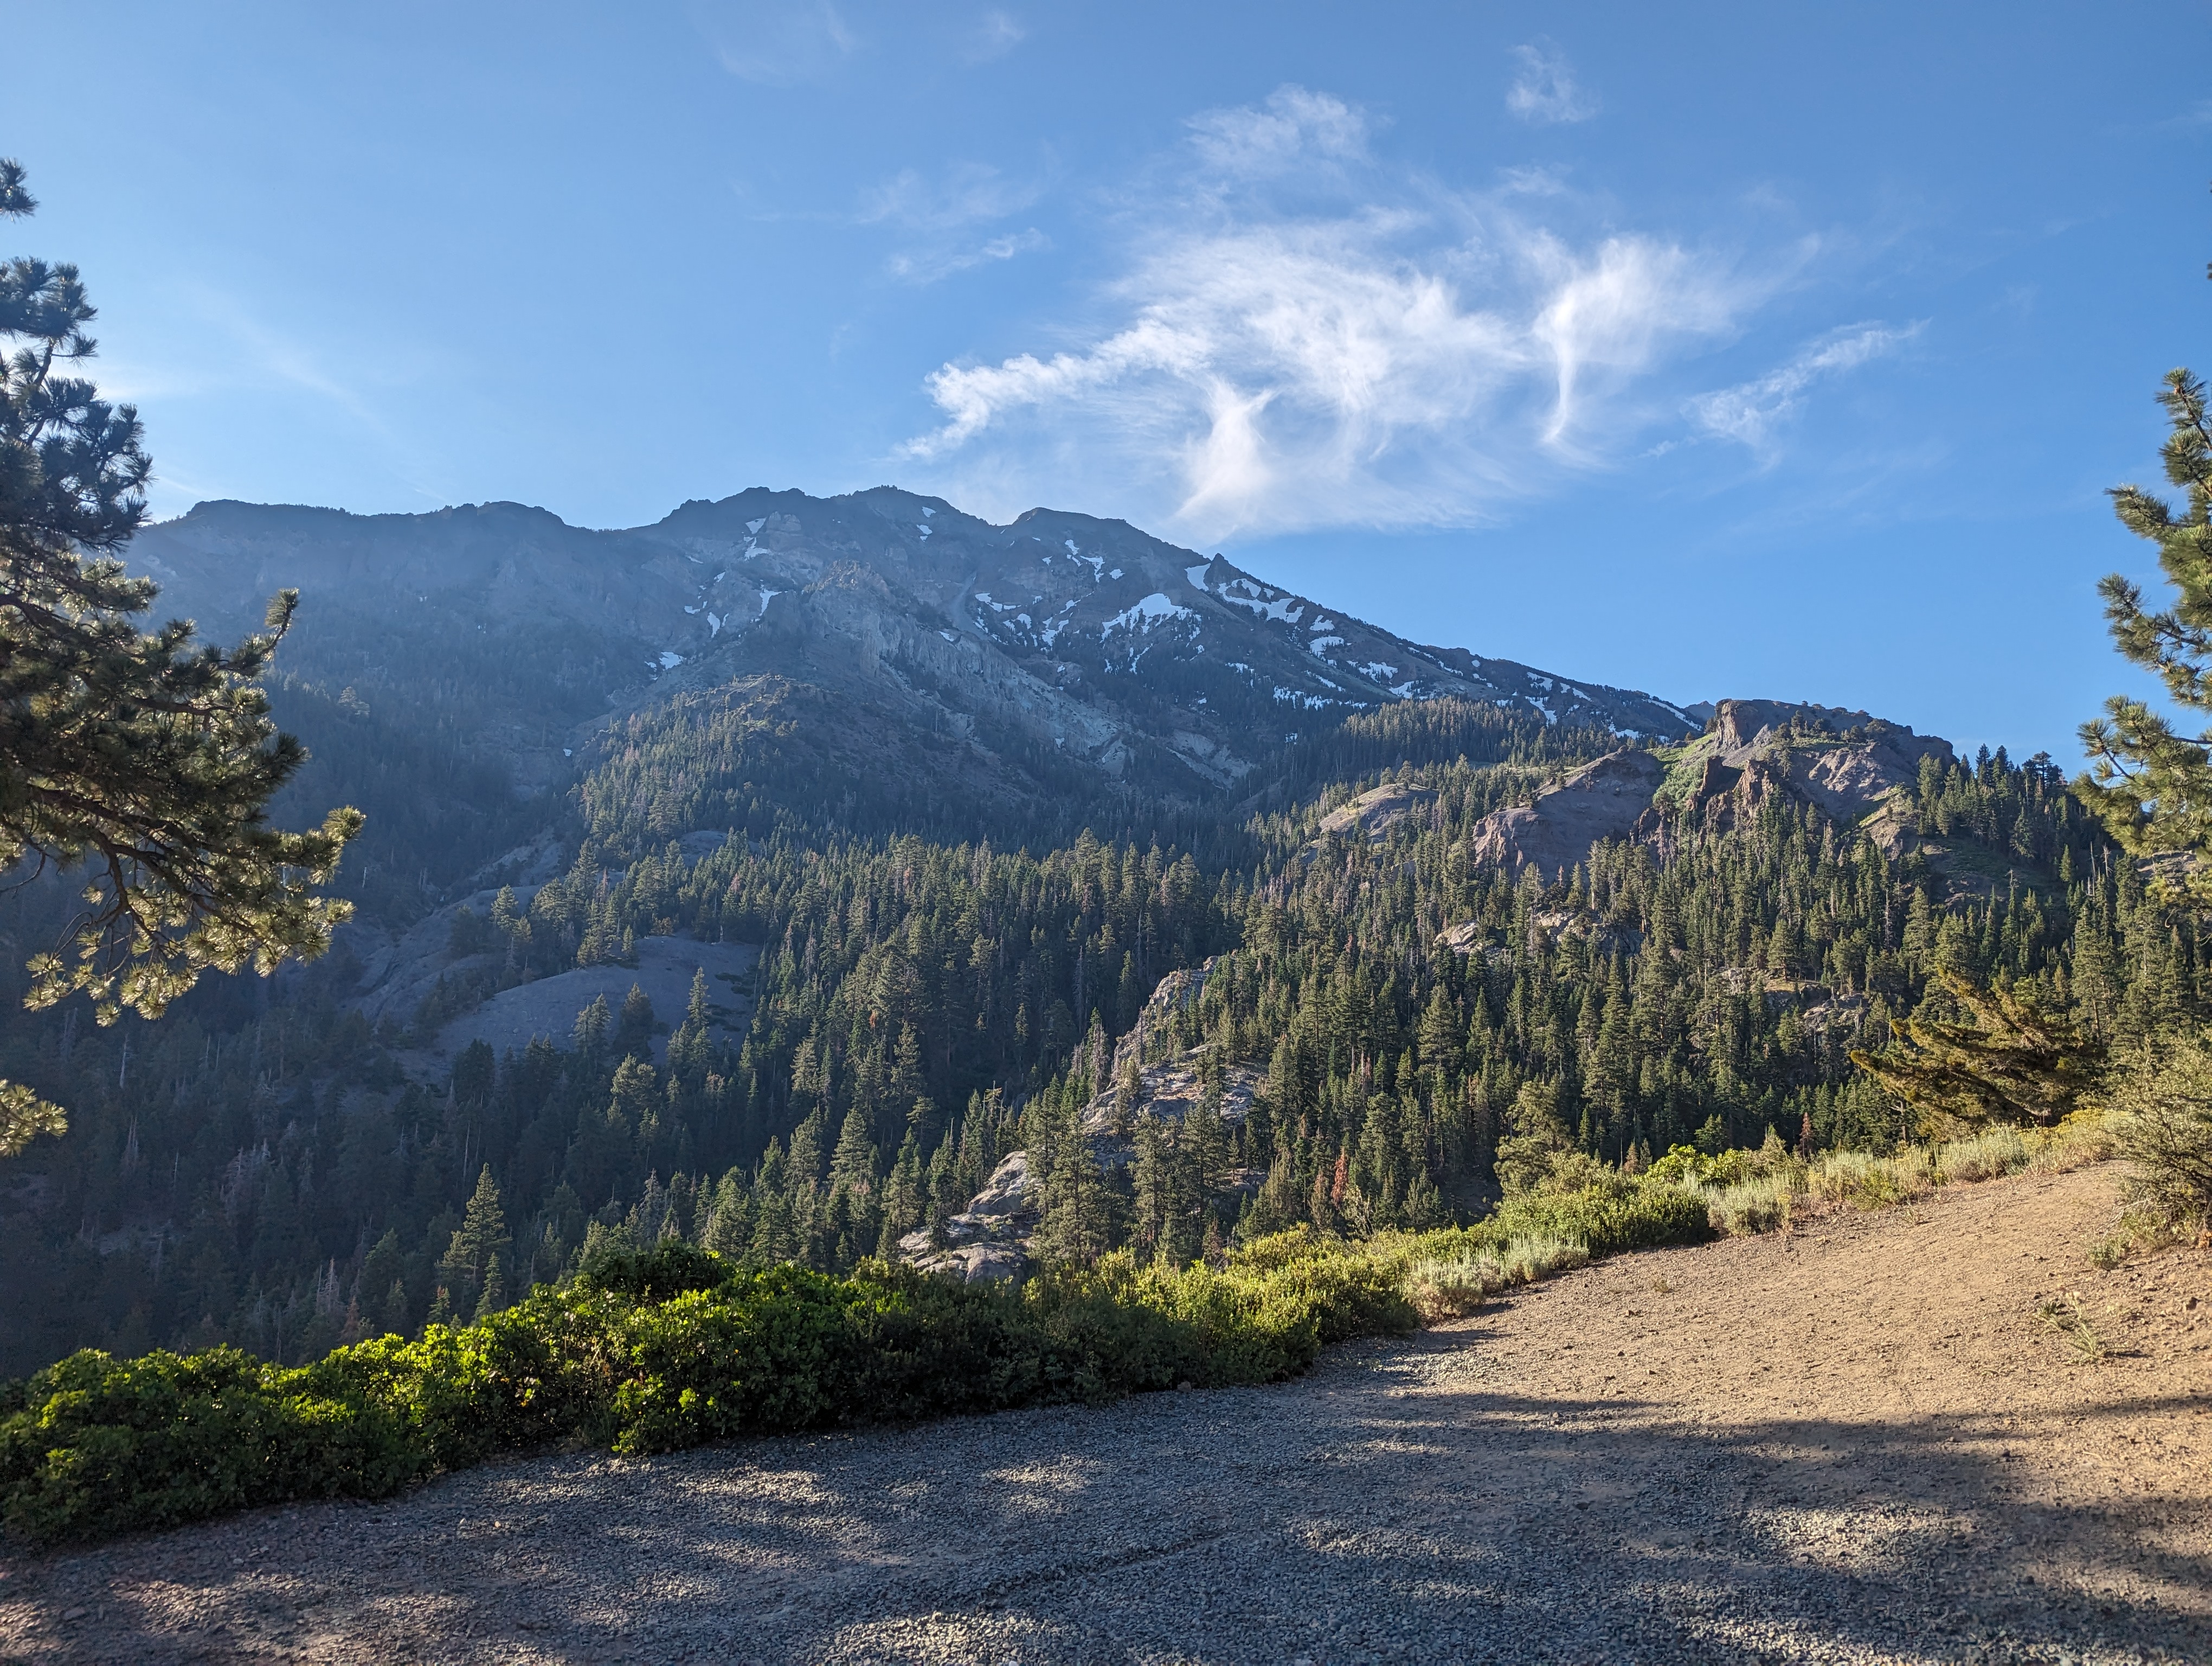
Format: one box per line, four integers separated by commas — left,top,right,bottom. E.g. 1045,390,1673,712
0,1234,1416,1545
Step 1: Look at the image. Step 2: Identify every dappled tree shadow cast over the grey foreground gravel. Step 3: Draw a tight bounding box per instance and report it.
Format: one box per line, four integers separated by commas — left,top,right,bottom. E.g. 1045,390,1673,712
17,1332,2212,1666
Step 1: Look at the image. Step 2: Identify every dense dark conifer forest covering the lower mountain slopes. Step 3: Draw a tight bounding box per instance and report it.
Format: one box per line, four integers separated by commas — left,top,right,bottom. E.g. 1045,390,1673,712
0,663,2205,1369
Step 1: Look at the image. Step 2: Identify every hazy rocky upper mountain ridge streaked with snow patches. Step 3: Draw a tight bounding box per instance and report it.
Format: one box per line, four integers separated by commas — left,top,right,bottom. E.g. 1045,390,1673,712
133,487,1699,836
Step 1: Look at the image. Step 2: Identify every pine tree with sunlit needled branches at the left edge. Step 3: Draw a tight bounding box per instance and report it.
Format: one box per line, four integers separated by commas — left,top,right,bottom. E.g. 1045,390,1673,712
0,162,361,1155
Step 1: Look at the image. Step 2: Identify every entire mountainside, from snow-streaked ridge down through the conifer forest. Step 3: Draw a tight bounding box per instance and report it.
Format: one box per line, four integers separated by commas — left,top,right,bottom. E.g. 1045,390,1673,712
0,478,2176,1374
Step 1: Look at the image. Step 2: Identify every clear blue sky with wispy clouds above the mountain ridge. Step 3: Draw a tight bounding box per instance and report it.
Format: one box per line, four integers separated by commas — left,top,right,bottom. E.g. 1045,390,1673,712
17,0,2212,763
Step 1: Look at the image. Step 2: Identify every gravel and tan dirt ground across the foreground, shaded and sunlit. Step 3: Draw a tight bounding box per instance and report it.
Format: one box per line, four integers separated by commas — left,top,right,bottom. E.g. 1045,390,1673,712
0,1168,2212,1666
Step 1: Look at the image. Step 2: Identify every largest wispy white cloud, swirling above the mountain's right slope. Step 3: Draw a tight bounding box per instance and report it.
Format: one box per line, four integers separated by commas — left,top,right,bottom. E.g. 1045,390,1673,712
903,88,1803,535
